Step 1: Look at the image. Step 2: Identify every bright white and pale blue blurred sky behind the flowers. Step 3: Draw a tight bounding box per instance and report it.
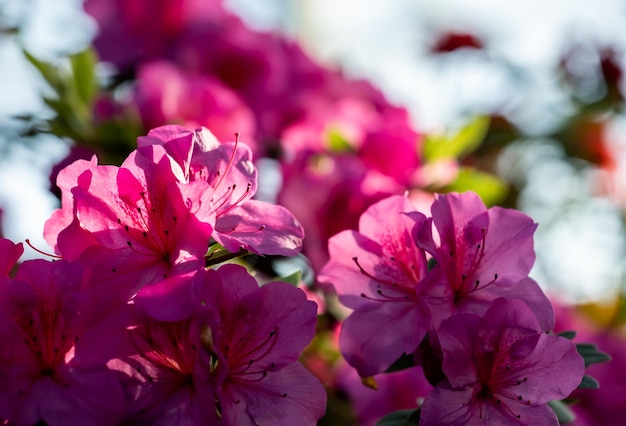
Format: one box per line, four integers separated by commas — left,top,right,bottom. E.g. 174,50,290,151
0,0,626,300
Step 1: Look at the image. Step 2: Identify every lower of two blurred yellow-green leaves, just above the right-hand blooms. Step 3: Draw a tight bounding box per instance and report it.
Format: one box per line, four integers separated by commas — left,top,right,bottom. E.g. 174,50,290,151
444,167,508,206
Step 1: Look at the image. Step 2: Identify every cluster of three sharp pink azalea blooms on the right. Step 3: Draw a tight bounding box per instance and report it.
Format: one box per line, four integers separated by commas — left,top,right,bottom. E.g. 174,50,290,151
319,192,585,425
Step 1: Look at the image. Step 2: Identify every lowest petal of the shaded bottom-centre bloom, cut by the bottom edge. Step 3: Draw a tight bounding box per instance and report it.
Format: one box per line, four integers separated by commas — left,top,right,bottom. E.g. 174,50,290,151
224,363,326,426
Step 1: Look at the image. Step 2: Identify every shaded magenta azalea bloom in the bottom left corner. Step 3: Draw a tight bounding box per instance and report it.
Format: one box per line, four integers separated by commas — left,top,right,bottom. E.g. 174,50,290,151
0,260,127,425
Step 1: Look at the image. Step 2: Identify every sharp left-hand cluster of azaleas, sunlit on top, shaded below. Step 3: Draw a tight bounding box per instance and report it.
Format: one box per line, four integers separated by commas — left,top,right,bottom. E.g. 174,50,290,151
0,126,326,425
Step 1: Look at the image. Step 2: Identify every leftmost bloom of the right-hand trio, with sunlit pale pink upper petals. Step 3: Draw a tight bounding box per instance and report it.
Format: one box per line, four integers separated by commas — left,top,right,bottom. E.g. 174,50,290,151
318,196,431,376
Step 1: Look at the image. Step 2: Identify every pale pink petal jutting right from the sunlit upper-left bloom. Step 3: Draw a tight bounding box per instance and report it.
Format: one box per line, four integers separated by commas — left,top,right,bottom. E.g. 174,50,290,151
215,200,304,256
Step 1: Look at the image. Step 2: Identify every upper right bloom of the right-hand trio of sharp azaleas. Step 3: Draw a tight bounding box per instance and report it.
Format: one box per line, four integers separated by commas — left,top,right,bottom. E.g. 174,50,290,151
418,192,554,331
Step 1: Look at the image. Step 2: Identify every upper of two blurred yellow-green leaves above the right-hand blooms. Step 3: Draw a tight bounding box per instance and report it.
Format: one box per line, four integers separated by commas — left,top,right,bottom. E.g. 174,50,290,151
423,116,490,162
